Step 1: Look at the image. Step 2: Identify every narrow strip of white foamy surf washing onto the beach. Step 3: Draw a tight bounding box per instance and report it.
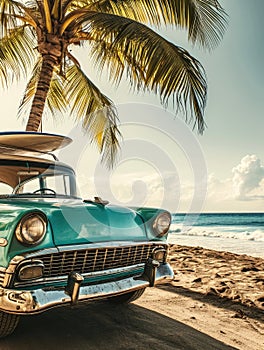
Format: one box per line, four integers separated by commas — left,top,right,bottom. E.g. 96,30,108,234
169,224,264,242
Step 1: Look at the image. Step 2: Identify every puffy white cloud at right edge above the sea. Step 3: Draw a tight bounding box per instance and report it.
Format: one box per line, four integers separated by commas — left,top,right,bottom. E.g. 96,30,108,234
232,154,264,200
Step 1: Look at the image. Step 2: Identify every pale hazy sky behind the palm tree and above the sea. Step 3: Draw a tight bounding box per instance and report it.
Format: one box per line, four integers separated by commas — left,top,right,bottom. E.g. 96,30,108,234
0,0,264,212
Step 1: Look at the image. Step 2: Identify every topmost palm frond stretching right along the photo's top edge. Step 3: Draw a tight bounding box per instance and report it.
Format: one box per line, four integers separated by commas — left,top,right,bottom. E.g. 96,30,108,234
78,0,227,49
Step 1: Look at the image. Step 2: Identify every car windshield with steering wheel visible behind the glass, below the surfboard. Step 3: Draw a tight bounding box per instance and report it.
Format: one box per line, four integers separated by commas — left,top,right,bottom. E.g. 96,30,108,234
0,160,77,197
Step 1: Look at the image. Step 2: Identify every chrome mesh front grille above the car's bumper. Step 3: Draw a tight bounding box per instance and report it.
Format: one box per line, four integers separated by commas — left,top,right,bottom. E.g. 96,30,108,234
38,244,159,278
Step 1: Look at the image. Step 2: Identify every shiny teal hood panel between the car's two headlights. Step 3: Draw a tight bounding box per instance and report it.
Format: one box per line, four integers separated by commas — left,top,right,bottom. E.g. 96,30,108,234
47,201,146,245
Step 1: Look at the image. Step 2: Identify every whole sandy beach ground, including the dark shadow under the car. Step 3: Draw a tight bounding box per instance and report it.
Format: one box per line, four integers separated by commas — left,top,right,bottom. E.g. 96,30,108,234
0,245,264,350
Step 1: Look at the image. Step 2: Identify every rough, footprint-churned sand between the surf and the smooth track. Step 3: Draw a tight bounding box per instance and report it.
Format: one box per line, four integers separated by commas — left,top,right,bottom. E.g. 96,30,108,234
170,245,264,312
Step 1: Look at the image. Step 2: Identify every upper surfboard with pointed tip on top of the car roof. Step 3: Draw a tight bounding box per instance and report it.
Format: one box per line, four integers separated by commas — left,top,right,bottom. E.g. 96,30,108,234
0,131,72,155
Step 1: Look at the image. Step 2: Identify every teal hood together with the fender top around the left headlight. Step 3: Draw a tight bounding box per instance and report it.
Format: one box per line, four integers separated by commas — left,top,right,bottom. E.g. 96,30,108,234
0,198,146,249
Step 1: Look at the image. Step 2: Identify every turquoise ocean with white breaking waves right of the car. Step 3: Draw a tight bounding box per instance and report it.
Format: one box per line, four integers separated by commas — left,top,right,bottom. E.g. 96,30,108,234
169,213,264,258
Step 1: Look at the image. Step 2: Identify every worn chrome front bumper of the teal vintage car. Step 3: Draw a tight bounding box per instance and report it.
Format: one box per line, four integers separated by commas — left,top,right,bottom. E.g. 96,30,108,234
0,260,173,315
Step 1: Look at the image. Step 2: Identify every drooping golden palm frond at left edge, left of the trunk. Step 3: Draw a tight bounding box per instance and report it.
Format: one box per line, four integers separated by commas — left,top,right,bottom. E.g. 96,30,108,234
0,26,37,85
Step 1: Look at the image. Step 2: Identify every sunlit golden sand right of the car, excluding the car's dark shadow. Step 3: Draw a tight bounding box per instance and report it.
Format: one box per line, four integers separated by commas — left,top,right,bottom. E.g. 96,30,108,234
137,245,264,350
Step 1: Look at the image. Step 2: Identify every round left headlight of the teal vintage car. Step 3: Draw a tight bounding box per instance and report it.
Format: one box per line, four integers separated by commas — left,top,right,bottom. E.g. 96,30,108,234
15,213,47,245
